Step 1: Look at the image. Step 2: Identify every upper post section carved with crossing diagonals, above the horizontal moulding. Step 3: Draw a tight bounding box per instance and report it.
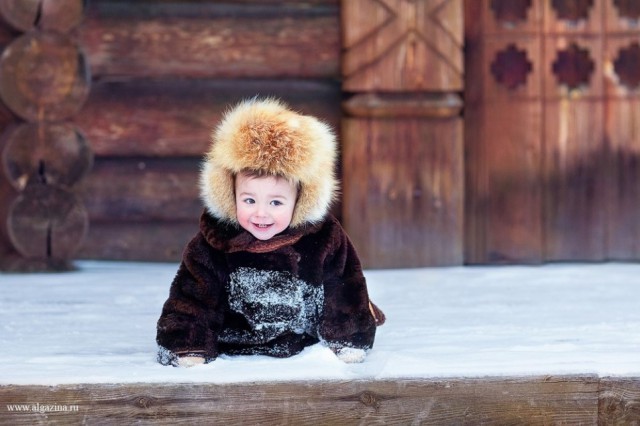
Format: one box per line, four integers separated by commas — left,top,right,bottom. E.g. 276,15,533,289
341,0,464,92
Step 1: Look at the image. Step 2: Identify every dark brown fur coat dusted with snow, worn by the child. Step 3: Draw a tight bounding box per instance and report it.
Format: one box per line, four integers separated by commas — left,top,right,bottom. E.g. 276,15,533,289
157,212,384,365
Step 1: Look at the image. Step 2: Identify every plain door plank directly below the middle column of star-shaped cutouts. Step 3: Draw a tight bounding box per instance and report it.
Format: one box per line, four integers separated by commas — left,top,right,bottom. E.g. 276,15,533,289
543,98,613,261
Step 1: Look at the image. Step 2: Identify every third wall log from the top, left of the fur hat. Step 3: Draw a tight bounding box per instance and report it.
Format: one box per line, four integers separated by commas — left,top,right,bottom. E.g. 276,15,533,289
78,158,203,224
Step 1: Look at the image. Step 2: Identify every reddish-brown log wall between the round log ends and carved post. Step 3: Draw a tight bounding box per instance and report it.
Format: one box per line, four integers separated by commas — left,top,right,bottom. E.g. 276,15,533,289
0,0,341,269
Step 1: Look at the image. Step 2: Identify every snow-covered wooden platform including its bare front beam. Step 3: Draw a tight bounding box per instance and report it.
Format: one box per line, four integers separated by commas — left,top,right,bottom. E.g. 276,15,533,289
0,262,640,426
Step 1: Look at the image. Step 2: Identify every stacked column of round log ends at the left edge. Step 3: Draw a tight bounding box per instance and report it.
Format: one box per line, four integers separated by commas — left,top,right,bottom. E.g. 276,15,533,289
0,0,93,271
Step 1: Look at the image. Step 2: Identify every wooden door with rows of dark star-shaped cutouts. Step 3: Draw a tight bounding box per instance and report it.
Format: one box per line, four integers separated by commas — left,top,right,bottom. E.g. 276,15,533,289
465,0,640,263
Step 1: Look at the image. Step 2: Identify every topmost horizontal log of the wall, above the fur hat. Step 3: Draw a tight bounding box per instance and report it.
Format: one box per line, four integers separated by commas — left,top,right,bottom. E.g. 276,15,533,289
76,2,340,78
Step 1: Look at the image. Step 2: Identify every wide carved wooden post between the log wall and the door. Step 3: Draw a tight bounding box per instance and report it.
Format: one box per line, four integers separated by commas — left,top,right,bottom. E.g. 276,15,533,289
342,0,464,268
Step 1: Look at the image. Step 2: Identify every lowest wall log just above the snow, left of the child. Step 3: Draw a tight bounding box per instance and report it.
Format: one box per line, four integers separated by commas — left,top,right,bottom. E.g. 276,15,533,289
76,218,198,262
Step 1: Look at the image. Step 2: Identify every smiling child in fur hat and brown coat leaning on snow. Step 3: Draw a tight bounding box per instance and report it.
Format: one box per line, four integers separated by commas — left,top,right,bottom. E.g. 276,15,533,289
156,98,384,367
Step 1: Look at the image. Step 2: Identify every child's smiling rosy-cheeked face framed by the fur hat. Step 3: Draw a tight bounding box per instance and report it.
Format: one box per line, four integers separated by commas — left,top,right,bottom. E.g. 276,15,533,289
235,173,297,240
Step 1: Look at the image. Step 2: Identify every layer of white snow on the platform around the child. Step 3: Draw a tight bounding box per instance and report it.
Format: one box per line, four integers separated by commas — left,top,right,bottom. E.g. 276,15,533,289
0,262,640,385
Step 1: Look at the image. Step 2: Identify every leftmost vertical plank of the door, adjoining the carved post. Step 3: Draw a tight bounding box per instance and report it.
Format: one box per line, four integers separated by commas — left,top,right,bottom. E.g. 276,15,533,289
464,17,544,264
